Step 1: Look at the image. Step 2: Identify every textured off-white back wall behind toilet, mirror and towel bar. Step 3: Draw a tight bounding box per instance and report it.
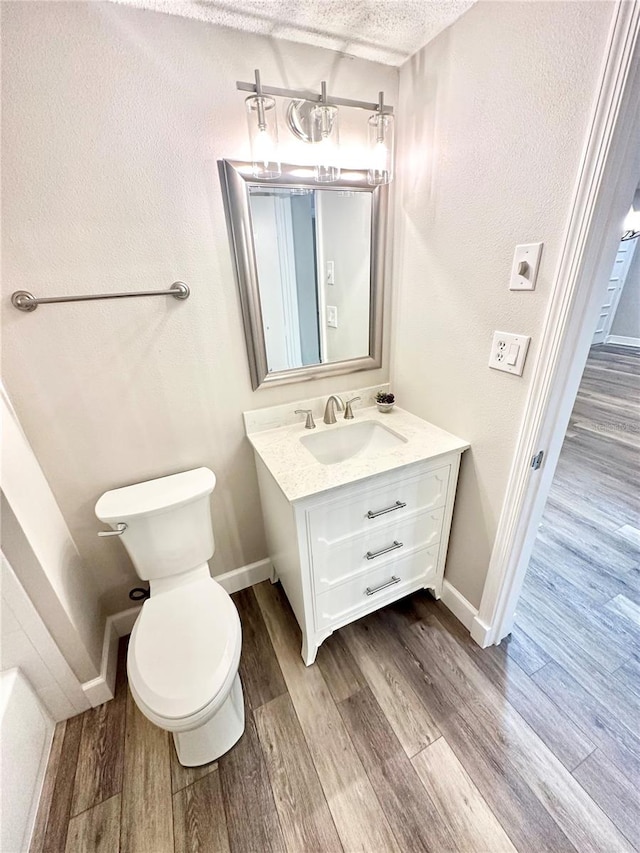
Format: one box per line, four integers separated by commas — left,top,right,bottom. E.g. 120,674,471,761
2,2,397,612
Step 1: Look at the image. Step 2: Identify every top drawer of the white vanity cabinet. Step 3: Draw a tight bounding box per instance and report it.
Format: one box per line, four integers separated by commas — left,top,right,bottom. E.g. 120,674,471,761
309,465,451,543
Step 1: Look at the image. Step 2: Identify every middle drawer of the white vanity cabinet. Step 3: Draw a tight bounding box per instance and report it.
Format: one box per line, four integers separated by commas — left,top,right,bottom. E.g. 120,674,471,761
311,507,444,594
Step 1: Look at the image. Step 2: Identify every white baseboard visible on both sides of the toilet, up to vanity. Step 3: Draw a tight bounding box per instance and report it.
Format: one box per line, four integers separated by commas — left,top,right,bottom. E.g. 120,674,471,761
82,559,272,708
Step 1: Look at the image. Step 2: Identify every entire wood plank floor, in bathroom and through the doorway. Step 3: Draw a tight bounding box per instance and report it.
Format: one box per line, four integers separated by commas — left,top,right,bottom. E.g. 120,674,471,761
31,347,640,853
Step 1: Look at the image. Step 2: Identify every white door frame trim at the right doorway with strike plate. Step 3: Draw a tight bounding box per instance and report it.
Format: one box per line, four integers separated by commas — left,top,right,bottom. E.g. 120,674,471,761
471,0,640,647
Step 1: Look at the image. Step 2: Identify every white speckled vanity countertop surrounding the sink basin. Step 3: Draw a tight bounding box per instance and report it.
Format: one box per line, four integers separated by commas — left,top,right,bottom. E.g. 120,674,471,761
247,406,469,501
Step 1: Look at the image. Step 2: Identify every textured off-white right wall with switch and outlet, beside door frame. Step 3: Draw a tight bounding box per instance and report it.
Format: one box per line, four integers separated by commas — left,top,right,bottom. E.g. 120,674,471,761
392,0,614,606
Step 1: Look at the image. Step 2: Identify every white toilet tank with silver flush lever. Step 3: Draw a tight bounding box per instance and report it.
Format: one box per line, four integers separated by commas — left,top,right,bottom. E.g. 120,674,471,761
95,468,216,580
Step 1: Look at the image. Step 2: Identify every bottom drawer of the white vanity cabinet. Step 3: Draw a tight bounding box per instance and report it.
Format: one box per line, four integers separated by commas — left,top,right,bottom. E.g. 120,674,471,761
315,545,439,631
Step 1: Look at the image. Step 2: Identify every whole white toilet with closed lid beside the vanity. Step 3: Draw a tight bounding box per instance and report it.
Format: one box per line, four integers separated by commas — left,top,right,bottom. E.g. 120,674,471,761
95,468,244,767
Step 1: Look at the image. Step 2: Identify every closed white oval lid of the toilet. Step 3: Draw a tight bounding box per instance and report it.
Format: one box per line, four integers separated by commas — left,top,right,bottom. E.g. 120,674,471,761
127,578,242,719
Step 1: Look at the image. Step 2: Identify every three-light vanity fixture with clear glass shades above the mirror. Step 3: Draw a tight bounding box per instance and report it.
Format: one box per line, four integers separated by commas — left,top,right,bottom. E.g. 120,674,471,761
236,70,394,186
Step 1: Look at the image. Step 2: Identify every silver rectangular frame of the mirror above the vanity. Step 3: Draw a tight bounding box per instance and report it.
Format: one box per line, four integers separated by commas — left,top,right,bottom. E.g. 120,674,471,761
218,160,389,391
